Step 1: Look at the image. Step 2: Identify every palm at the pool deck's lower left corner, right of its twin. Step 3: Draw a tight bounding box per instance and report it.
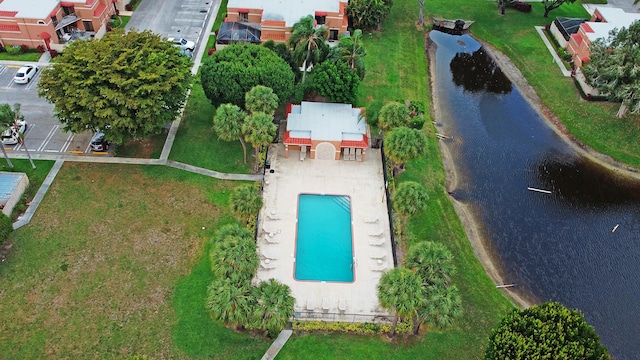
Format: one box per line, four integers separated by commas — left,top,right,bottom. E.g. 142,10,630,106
253,279,295,337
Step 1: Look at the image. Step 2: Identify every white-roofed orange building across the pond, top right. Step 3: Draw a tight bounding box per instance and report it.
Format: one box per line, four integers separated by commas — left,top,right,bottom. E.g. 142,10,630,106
556,7,640,68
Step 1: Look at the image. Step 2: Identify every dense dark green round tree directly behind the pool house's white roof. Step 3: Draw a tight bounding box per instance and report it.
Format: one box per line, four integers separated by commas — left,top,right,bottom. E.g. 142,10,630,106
312,61,360,104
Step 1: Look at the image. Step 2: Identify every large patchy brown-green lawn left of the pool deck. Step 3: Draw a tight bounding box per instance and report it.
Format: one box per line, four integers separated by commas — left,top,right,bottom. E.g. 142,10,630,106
0,163,269,359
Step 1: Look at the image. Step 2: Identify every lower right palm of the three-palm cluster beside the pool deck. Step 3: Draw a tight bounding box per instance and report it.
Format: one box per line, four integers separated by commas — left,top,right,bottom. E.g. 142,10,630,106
413,285,462,335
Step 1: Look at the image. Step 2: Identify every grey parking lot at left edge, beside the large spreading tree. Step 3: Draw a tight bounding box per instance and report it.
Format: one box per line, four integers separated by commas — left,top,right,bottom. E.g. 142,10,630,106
0,65,92,154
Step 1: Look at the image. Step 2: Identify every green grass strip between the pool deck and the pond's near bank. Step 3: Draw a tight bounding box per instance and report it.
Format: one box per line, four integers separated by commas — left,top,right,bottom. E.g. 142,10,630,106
278,0,513,359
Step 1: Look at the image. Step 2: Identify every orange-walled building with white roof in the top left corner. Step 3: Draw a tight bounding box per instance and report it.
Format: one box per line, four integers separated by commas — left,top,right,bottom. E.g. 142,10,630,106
0,0,117,50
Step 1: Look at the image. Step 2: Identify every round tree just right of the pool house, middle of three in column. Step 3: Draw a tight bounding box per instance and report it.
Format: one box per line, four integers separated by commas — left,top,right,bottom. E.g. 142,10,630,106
384,126,427,176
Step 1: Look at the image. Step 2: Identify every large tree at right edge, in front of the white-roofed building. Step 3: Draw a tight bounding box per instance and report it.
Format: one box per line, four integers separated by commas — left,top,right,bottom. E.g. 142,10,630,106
582,21,640,118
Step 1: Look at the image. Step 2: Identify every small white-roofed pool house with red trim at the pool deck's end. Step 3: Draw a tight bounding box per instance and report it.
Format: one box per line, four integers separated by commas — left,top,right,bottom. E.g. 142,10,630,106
283,101,369,161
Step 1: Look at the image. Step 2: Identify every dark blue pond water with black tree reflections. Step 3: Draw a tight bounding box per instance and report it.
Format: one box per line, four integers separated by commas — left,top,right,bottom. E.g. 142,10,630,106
431,31,640,359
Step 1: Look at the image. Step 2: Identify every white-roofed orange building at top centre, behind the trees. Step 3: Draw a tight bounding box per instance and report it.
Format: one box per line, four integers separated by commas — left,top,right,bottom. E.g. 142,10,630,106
225,0,348,42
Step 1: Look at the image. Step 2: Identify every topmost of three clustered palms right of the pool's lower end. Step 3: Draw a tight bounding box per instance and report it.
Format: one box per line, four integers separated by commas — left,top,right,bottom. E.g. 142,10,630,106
405,241,456,286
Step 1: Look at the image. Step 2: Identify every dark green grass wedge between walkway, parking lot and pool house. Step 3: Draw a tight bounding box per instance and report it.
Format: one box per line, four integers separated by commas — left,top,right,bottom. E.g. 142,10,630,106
169,82,253,174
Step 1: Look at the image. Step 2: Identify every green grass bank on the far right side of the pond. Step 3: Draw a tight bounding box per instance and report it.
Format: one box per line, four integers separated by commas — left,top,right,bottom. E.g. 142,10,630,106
426,0,640,167
